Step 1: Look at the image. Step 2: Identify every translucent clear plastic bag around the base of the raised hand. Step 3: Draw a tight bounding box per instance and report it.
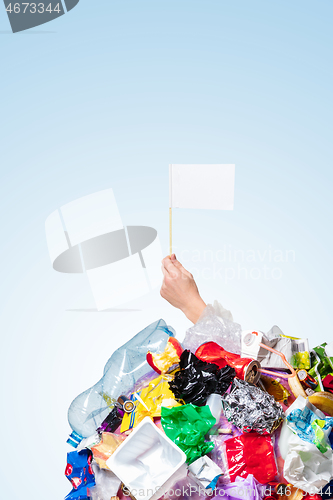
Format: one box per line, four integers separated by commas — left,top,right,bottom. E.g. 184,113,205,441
183,302,242,354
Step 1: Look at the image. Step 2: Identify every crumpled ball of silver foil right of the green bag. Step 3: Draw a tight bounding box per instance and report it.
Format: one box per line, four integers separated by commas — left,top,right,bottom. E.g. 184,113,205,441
222,378,284,434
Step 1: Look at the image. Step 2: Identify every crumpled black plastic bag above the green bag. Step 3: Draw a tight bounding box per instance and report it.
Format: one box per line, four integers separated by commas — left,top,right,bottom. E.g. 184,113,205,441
169,350,235,406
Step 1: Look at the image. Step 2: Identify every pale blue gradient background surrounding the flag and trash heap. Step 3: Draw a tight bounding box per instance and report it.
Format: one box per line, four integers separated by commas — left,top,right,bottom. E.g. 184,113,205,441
0,0,333,500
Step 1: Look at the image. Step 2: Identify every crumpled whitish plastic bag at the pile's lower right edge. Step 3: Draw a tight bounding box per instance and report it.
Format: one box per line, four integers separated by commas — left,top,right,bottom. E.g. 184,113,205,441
283,434,333,494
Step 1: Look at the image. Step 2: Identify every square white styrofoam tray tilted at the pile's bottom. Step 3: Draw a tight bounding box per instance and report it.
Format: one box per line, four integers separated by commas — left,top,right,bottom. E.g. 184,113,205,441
106,417,186,500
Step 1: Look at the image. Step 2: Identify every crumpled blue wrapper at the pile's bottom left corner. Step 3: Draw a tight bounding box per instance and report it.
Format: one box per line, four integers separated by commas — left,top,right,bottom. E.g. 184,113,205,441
65,450,95,500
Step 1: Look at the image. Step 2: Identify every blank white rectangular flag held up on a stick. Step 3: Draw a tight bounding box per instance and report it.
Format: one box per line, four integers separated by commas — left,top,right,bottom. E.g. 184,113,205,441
169,164,235,210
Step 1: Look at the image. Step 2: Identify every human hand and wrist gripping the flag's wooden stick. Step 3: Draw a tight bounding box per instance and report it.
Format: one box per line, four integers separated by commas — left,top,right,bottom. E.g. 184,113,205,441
160,254,206,323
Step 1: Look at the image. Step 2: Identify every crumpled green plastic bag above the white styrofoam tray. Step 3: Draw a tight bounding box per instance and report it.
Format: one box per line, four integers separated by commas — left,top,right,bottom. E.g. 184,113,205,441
161,404,216,464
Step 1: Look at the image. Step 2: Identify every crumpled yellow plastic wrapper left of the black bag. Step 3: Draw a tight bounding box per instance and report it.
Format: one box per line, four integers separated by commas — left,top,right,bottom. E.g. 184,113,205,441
120,375,181,432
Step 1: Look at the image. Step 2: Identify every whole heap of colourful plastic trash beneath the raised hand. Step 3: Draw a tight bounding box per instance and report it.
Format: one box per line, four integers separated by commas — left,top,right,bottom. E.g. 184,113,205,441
65,303,333,500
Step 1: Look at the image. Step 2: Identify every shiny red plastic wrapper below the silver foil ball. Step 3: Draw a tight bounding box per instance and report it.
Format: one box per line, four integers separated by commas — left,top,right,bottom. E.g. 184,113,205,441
225,432,277,484
